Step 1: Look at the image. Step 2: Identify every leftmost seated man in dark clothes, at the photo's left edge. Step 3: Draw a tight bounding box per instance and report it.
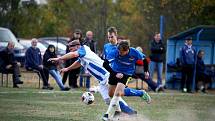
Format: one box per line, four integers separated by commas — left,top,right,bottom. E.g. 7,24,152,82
0,41,23,88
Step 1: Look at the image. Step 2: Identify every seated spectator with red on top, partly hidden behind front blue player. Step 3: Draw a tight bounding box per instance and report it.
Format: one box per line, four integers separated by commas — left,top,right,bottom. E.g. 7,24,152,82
135,47,164,92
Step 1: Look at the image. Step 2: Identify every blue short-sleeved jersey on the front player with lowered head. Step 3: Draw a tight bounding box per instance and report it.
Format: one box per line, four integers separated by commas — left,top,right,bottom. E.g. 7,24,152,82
108,48,144,75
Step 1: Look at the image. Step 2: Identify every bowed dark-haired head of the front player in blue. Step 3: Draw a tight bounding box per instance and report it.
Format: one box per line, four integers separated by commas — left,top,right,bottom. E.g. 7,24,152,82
118,40,130,56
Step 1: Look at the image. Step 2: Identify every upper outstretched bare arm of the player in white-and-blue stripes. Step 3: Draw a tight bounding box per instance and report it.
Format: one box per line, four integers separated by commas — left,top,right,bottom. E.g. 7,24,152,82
48,51,79,61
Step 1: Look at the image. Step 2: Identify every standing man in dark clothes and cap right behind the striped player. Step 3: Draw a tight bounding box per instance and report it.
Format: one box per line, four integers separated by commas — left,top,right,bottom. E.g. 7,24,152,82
62,29,82,88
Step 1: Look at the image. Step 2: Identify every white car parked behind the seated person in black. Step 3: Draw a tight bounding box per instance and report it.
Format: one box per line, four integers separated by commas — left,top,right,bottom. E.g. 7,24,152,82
39,40,66,56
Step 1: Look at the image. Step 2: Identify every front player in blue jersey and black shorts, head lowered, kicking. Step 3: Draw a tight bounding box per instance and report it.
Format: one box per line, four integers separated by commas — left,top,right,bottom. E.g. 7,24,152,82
102,41,151,121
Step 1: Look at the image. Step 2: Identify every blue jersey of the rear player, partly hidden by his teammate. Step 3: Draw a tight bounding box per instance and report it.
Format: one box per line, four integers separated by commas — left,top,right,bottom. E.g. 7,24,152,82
103,43,117,62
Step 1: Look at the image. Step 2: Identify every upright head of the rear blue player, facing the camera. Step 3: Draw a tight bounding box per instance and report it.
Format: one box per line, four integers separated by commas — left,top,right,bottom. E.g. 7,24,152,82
108,27,117,44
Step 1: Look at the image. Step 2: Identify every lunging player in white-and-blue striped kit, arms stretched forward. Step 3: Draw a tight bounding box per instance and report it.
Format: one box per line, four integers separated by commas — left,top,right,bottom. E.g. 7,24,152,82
49,40,110,104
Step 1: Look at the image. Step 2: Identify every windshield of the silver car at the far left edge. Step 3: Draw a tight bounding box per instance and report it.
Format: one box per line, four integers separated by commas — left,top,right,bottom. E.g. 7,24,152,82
0,30,17,42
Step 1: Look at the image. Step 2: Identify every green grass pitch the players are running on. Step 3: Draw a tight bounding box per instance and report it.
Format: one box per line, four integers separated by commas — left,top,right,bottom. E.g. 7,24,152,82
0,87,215,121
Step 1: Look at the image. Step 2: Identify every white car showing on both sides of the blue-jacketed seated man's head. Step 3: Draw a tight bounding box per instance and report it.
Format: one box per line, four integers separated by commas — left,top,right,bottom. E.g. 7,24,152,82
19,38,47,55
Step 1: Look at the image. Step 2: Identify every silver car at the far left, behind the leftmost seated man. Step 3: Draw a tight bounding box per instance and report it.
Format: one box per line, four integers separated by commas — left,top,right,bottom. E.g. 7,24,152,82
0,27,25,65
